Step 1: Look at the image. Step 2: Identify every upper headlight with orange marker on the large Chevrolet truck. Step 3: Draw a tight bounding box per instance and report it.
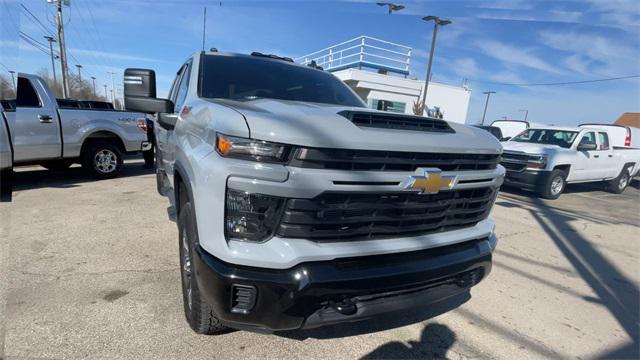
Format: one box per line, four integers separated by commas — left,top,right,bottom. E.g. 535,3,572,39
216,134,291,163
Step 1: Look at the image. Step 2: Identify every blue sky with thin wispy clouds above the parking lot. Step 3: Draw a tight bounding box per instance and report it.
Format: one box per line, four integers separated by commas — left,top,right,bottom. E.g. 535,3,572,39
0,0,640,124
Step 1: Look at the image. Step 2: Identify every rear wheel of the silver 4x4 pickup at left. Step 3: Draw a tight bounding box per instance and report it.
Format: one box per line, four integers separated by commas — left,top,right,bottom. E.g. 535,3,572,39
82,141,123,179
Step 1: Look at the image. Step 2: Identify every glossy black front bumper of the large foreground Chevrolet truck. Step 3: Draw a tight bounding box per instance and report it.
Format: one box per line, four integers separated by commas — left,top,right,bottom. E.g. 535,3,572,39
194,235,496,331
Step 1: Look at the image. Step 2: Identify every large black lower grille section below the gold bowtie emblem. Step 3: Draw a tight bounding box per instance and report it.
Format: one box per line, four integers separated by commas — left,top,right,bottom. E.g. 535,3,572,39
277,187,495,241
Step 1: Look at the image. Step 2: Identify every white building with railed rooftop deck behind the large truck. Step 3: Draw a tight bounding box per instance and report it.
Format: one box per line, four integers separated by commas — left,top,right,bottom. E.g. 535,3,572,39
296,36,471,123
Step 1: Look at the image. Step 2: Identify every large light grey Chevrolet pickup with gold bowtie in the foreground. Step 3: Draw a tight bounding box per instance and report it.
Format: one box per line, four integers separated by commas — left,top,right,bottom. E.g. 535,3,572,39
124,51,504,334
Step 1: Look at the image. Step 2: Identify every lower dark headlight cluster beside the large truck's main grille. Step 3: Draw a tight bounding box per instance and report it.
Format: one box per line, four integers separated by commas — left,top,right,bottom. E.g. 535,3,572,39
224,189,284,242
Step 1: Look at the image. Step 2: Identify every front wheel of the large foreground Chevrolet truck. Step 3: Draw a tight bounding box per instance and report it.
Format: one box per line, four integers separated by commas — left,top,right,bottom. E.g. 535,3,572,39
178,202,228,335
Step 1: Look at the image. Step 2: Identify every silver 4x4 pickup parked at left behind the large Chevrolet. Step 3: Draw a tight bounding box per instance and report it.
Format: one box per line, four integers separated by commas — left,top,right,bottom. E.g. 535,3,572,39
6,73,151,179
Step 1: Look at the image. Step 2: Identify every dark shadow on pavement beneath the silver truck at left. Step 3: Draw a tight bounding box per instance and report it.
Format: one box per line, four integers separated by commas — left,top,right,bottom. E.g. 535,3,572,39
13,160,155,196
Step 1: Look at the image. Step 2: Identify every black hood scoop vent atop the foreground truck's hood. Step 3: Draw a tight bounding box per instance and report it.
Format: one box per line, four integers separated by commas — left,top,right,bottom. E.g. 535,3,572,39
338,111,455,133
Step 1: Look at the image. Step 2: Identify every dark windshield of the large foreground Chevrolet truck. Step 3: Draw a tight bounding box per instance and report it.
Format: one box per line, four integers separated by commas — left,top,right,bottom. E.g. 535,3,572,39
200,55,364,107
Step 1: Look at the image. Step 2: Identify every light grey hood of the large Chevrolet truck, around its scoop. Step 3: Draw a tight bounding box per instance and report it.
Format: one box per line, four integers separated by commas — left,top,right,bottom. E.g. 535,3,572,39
208,99,502,154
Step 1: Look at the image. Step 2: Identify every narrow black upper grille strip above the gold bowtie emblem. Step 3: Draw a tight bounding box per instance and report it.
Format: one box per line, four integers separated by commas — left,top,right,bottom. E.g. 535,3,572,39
289,148,500,171
